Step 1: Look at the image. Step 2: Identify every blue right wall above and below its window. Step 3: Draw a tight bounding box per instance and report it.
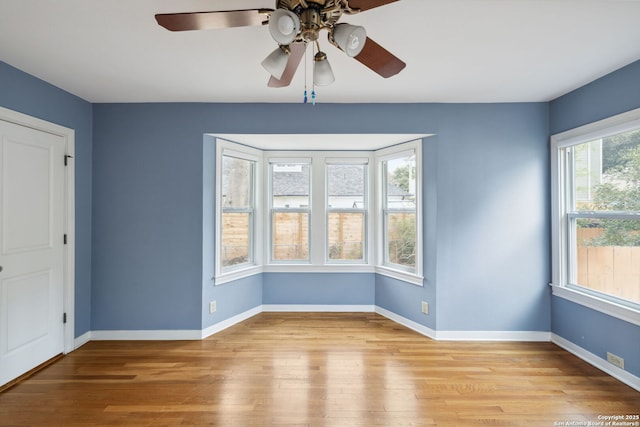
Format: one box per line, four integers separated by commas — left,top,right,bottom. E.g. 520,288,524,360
550,57,640,376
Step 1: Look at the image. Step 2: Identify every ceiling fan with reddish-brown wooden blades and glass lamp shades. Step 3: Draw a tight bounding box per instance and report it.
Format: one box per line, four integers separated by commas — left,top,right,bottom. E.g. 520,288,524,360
155,0,406,87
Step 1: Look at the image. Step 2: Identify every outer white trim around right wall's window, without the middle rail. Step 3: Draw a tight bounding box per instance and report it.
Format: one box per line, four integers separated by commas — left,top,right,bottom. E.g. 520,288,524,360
550,108,640,325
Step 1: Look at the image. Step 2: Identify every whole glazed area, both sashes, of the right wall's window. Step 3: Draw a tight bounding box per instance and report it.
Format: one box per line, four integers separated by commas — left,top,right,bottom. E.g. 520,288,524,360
561,129,640,307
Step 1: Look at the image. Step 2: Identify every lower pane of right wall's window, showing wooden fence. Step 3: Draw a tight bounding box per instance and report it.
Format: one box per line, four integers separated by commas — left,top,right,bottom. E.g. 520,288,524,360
576,219,640,304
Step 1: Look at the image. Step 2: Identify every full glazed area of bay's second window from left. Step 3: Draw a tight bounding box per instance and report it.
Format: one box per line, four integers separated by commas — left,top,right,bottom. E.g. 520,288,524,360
270,159,311,263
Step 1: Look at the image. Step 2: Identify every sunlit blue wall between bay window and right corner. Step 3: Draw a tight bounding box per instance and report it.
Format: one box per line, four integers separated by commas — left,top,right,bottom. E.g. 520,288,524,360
436,104,551,331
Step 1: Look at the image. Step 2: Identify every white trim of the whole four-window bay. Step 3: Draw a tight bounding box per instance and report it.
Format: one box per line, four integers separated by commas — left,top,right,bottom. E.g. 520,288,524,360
213,135,429,286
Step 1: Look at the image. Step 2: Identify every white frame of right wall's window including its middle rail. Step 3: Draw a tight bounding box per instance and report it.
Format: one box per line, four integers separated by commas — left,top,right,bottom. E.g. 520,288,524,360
550,109,640,325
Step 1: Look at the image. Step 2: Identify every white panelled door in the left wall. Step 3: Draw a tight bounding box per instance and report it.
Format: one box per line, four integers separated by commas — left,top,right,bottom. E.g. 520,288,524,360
0,120,65,385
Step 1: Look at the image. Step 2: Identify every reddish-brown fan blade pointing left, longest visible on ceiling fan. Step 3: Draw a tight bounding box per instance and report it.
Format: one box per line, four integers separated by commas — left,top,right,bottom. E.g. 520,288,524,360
156,9,272,31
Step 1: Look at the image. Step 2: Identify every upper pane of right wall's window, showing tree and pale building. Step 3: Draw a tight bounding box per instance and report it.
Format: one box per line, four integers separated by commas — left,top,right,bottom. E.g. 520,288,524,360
572,130,640,212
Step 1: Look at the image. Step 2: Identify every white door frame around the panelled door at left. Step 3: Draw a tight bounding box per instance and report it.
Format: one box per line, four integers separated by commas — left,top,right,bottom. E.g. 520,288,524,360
0,107,76,354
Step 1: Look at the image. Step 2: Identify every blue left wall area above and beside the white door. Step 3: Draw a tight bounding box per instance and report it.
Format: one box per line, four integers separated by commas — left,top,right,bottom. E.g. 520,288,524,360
0,61,93,336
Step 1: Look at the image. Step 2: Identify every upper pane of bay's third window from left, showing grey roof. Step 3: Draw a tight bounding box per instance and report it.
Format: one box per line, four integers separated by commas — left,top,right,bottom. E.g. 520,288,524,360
327,165,366,209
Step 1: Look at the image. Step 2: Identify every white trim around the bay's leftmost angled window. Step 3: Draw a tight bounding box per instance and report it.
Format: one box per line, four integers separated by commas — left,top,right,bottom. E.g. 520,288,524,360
214,138,263,285
